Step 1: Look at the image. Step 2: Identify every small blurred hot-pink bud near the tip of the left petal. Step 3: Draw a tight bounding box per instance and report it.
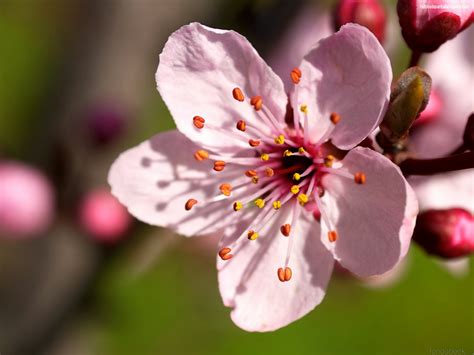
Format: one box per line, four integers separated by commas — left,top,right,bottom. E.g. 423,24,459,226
79,188,132,243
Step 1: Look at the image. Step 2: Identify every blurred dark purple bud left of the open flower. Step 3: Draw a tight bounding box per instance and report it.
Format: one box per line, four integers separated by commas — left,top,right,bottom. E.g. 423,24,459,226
86,104,126,146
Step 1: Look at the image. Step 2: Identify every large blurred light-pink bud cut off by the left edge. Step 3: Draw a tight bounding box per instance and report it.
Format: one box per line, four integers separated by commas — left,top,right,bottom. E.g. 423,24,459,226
0,161,54,238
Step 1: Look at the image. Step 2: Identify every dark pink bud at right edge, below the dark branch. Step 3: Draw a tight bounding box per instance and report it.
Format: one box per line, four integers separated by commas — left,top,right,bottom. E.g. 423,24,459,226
413,208,474,259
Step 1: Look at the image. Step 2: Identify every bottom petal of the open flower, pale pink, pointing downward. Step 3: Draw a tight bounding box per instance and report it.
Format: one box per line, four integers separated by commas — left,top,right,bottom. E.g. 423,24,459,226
217,208,334,332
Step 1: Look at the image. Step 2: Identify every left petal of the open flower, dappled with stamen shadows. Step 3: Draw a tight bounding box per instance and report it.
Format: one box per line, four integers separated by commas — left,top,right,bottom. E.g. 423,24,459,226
109,131,241,236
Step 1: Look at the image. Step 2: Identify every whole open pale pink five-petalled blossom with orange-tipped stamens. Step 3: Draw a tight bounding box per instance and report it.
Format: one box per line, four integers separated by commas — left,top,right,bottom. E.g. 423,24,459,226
109,23,417,331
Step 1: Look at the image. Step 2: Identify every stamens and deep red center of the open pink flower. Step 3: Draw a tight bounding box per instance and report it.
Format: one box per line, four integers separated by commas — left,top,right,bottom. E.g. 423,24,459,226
184,68,366,282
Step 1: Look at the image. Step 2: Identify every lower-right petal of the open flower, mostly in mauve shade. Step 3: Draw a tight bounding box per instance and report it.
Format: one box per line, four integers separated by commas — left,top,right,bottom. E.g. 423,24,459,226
323,147,418,277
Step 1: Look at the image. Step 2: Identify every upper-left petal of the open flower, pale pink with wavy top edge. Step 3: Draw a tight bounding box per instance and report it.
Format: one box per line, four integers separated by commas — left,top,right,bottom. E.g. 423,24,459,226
156,23,288,153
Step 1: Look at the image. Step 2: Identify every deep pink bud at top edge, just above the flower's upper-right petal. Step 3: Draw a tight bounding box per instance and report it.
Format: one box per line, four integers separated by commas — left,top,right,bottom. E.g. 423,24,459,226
334,0,386,42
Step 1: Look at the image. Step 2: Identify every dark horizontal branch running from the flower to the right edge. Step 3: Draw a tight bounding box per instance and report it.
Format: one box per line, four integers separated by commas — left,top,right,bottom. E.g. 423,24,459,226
400,152,474,176
